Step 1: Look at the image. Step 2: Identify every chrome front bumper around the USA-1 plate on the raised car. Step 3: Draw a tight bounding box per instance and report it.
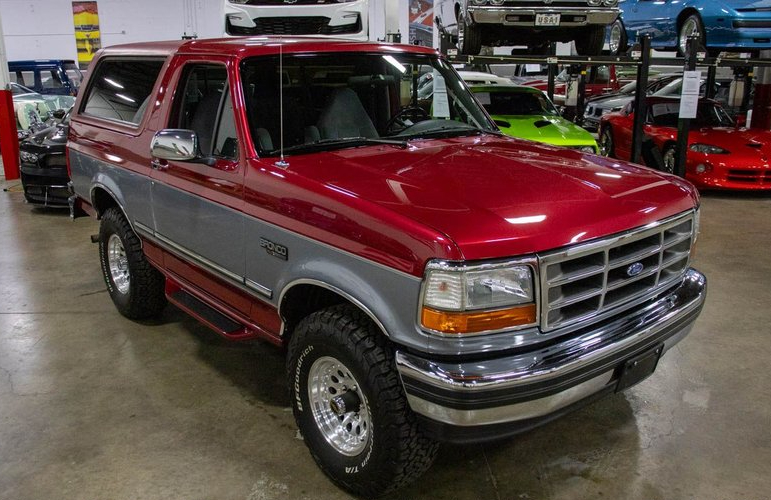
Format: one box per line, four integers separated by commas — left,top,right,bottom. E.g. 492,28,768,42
468,5,619,29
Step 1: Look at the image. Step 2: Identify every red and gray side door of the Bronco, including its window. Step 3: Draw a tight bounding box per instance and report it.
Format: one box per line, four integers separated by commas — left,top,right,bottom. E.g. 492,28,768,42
151,60,248,312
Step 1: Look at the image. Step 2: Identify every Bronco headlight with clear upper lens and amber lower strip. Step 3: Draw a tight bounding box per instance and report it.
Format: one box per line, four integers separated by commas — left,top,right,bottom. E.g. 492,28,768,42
420,262,536,335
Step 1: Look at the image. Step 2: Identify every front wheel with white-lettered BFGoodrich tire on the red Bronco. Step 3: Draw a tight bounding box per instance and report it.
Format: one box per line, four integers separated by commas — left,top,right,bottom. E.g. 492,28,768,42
287,305,437,497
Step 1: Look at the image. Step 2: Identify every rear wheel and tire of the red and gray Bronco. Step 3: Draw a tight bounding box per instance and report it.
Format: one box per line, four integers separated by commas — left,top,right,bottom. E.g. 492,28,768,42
99,207,166,319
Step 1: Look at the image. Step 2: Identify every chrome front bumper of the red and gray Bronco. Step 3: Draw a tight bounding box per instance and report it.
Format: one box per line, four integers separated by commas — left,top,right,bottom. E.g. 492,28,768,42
396,269,706,441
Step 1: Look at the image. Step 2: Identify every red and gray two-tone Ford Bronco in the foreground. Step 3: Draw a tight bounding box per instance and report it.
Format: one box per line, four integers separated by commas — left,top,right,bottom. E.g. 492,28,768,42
68,37,706,496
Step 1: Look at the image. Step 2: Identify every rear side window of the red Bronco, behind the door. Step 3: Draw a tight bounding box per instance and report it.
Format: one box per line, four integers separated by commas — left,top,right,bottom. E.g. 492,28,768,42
81,59,163,125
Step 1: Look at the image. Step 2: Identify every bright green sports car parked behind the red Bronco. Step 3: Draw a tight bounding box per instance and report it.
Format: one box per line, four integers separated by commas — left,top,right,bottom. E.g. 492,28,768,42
471,85,599,153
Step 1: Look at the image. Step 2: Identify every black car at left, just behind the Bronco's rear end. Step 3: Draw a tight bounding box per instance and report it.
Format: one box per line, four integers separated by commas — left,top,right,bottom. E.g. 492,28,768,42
19,109,70,207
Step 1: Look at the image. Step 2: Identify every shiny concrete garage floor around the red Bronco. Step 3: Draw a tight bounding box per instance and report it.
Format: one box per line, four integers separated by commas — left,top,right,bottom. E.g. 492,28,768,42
0,174,771,500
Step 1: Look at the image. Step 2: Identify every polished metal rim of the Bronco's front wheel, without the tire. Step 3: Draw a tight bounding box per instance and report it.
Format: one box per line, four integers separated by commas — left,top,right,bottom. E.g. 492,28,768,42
308,356,371,457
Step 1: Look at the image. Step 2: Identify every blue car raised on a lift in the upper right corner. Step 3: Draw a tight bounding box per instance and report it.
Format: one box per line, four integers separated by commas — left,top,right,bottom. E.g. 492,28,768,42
607,0,771,54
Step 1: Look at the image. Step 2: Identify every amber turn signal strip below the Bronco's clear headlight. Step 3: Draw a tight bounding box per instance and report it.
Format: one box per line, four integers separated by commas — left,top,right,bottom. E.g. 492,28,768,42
421,304,535,335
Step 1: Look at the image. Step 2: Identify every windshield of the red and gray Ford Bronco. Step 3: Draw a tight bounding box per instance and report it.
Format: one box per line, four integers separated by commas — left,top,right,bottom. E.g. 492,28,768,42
241,53,497,156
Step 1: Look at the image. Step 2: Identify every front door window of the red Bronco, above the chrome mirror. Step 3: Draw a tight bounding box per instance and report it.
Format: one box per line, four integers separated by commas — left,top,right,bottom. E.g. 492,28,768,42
169,64,238,159
